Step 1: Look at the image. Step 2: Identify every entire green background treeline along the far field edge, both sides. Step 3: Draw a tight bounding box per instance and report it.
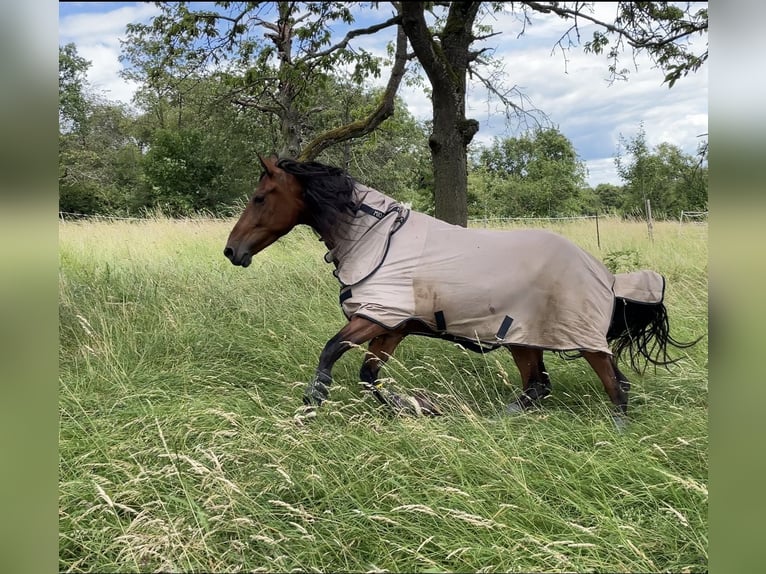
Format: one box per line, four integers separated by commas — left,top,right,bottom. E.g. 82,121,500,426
59,44,707,222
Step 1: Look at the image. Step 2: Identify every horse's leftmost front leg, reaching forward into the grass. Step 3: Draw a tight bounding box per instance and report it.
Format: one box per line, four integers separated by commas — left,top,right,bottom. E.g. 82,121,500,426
303,317,386,407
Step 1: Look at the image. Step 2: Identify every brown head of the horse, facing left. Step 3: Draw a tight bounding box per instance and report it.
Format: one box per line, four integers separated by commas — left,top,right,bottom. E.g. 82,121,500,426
223,155,305,267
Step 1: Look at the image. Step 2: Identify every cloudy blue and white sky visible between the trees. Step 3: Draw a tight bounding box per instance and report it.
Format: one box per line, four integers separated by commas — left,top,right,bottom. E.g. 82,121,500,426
59,2,708,186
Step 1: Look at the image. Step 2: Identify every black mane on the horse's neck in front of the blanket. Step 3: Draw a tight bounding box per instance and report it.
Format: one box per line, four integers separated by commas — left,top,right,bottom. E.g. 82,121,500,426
277,158,356,237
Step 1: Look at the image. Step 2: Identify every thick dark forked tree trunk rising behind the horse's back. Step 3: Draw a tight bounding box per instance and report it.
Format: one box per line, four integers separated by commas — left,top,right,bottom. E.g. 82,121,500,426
400,2,481,227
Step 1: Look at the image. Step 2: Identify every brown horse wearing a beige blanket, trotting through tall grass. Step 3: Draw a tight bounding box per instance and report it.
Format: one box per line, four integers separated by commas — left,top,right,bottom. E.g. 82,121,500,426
223,155,699,428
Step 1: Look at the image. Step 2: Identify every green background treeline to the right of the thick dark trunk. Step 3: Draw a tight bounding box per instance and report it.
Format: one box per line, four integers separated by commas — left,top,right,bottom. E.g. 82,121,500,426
468,126,708,219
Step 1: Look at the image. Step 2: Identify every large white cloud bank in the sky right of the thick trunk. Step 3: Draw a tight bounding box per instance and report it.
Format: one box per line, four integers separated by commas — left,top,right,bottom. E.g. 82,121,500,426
469,25,707,183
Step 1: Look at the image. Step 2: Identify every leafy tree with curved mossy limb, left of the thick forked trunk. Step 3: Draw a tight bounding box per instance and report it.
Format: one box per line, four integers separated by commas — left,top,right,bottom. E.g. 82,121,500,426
123,2,407,160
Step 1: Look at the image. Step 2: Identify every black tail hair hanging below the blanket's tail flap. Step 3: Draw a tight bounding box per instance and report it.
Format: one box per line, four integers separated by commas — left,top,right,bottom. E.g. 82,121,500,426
606,297,702,373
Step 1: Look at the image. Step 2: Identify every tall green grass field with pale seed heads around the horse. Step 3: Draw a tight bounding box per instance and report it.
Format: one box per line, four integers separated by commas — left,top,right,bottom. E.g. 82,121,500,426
59,219,708,572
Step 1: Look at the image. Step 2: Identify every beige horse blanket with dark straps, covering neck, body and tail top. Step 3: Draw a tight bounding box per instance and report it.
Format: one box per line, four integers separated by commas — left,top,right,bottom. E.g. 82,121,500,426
325,183,664,353
